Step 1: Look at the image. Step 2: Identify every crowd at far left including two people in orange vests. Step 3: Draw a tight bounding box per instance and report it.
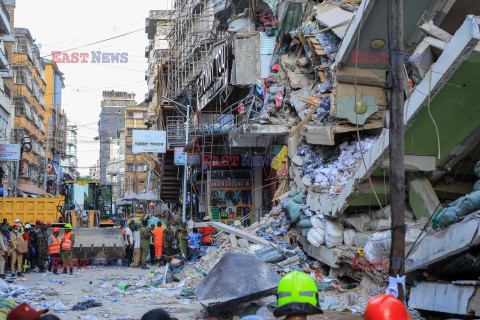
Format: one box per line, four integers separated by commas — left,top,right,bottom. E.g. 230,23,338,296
0,219,75,279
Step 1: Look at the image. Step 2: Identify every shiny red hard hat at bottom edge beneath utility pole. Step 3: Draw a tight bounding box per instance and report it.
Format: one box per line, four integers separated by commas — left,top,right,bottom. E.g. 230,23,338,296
363,294,409,320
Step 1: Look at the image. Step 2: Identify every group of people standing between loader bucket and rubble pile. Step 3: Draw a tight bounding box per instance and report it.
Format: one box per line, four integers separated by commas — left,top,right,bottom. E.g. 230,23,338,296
120,219,215,269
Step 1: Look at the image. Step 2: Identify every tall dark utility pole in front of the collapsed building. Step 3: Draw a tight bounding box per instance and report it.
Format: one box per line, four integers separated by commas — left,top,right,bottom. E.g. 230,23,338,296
387,0,405,301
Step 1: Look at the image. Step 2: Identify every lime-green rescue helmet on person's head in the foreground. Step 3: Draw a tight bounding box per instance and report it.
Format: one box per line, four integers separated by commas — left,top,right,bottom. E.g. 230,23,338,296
273,271,323,320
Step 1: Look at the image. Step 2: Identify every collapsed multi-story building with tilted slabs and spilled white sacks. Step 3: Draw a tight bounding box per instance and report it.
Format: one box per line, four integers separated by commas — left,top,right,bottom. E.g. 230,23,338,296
145,0,480,315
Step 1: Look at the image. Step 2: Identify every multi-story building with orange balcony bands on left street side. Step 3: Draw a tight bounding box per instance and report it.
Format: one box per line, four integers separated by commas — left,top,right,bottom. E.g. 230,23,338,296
13,28,46,188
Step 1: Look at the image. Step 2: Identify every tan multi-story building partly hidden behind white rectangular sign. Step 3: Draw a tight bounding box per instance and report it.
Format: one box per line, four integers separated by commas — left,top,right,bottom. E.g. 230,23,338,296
125,102,150,194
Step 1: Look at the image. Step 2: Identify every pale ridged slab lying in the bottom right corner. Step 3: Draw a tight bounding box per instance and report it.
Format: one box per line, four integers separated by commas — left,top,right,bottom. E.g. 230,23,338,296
408,281,480,317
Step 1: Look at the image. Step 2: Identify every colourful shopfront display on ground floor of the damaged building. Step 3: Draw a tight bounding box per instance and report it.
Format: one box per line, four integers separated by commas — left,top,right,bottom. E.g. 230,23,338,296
208,170,253,226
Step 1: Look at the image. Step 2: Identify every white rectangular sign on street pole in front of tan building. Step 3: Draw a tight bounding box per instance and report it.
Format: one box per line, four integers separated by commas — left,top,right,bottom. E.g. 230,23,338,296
132,130,167,153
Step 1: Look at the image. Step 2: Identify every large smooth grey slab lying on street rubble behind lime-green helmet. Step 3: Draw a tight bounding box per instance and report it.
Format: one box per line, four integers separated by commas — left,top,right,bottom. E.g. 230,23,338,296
195,252,281,315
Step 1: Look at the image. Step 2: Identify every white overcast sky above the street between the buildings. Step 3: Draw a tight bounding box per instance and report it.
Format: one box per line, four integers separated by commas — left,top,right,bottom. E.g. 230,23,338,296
15,0,171,175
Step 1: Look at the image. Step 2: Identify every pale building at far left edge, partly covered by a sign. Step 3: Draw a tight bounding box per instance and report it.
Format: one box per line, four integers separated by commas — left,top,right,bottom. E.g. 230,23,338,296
0,0,15,189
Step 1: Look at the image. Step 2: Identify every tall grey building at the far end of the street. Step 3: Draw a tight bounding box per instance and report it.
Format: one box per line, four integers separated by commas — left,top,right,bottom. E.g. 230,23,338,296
98,91,137,183
